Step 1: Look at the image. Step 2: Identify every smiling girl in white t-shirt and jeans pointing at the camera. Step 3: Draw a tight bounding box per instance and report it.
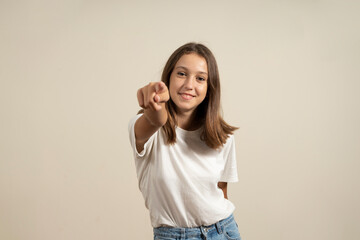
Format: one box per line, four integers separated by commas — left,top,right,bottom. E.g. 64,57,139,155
129,43,241,240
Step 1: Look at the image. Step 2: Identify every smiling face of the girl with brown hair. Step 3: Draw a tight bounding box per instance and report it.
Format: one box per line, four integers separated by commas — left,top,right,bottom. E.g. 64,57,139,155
169,53,208,114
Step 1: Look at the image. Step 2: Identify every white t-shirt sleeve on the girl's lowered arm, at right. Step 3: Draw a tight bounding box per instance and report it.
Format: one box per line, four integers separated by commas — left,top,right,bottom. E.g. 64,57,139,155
219,135,239,182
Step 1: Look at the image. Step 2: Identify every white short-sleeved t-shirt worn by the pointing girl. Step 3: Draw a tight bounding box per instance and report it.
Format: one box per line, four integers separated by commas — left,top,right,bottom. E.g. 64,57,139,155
129,114,238,228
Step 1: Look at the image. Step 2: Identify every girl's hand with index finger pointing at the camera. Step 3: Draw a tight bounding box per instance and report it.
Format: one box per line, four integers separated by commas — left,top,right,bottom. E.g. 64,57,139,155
137,82,169,111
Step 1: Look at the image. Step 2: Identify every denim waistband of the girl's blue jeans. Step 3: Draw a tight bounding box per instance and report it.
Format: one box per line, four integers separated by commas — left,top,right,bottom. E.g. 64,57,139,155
153,214,234,237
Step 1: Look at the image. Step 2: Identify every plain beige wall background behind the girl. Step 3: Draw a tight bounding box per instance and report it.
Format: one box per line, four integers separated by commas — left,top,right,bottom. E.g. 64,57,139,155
0,0,360,240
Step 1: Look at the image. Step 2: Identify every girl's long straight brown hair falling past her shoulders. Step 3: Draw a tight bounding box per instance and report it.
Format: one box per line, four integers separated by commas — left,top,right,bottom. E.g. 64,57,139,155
161,42,238,149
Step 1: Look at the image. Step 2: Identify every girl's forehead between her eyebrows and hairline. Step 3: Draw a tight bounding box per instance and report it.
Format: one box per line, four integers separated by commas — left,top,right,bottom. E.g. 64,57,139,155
175,53,208,73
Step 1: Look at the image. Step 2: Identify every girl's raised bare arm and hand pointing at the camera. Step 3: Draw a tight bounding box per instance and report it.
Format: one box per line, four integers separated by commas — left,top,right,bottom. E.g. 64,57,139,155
135,82,169,152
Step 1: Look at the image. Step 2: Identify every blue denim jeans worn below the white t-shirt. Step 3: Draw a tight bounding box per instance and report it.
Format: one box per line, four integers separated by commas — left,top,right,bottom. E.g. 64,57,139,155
154,214,241,240
